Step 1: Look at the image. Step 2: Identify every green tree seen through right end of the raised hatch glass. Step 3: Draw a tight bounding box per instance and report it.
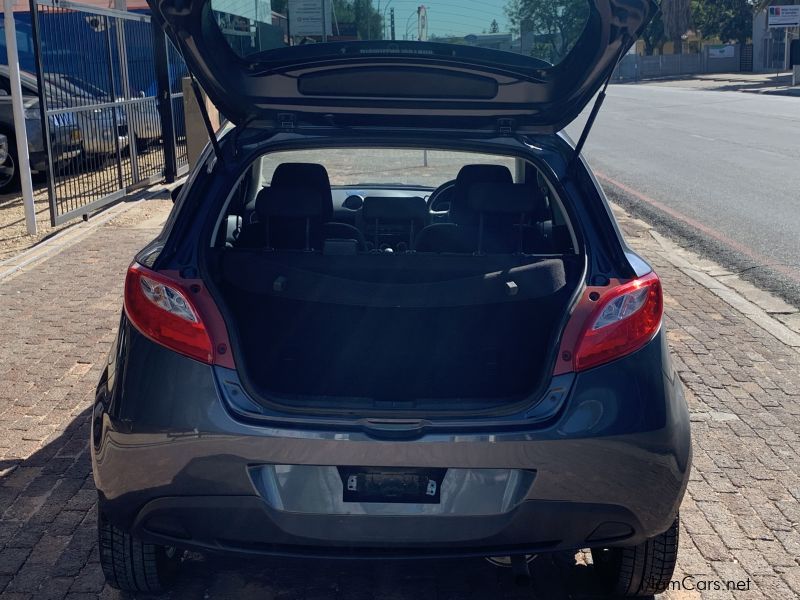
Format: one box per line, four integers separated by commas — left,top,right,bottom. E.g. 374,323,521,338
505,0,589,64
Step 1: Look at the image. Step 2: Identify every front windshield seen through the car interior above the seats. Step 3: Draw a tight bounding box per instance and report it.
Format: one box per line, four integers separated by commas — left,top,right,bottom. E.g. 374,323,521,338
261,148,514,188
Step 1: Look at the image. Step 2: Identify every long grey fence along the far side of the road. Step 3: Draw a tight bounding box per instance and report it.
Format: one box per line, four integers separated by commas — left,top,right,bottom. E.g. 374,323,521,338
613,45,742,81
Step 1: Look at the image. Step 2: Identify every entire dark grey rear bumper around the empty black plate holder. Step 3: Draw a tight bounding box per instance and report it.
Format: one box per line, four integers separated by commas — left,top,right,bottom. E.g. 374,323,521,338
92,319,691,557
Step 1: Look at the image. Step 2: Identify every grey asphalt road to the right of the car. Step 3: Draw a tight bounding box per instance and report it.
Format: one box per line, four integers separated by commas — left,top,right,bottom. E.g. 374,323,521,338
567,84,800,306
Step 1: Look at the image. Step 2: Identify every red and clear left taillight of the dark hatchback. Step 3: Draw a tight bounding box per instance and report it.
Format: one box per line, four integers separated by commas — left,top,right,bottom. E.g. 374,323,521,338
125,263,214,364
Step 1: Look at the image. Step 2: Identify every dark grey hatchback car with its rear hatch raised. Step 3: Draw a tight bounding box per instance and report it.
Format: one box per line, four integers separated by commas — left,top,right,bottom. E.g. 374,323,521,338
92,0,691,596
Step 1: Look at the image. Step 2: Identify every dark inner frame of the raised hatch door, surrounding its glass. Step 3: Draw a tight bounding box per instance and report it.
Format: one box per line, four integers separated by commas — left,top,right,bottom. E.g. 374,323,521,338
149,0,657,132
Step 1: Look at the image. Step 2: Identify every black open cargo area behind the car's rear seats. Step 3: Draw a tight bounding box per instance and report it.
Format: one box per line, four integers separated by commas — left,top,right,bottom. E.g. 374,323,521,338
212,248,582,410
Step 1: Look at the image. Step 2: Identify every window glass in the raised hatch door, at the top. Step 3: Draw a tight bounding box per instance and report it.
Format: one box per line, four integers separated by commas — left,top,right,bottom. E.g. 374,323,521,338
211,0,589,65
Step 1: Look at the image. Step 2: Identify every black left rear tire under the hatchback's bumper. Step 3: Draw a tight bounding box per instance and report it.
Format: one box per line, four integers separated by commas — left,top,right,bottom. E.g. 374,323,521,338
97,514,180,594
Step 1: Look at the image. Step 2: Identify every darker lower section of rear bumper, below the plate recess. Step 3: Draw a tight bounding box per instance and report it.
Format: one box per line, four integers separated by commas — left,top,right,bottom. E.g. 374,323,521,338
132,496,642,559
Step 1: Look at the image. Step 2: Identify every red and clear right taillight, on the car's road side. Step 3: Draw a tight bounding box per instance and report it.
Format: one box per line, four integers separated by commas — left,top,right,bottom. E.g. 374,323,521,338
574,273,664,371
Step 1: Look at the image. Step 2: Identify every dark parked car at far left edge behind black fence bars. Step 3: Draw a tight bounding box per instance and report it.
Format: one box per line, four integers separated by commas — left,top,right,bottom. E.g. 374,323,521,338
0,70,82,193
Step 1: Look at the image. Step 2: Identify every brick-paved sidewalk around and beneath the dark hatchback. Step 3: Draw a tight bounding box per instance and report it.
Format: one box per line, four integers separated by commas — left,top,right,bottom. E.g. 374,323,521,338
0,195,800,600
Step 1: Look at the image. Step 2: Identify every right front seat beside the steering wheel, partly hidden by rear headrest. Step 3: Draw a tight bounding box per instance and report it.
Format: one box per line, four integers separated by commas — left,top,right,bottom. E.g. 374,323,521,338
414,165,514,254
